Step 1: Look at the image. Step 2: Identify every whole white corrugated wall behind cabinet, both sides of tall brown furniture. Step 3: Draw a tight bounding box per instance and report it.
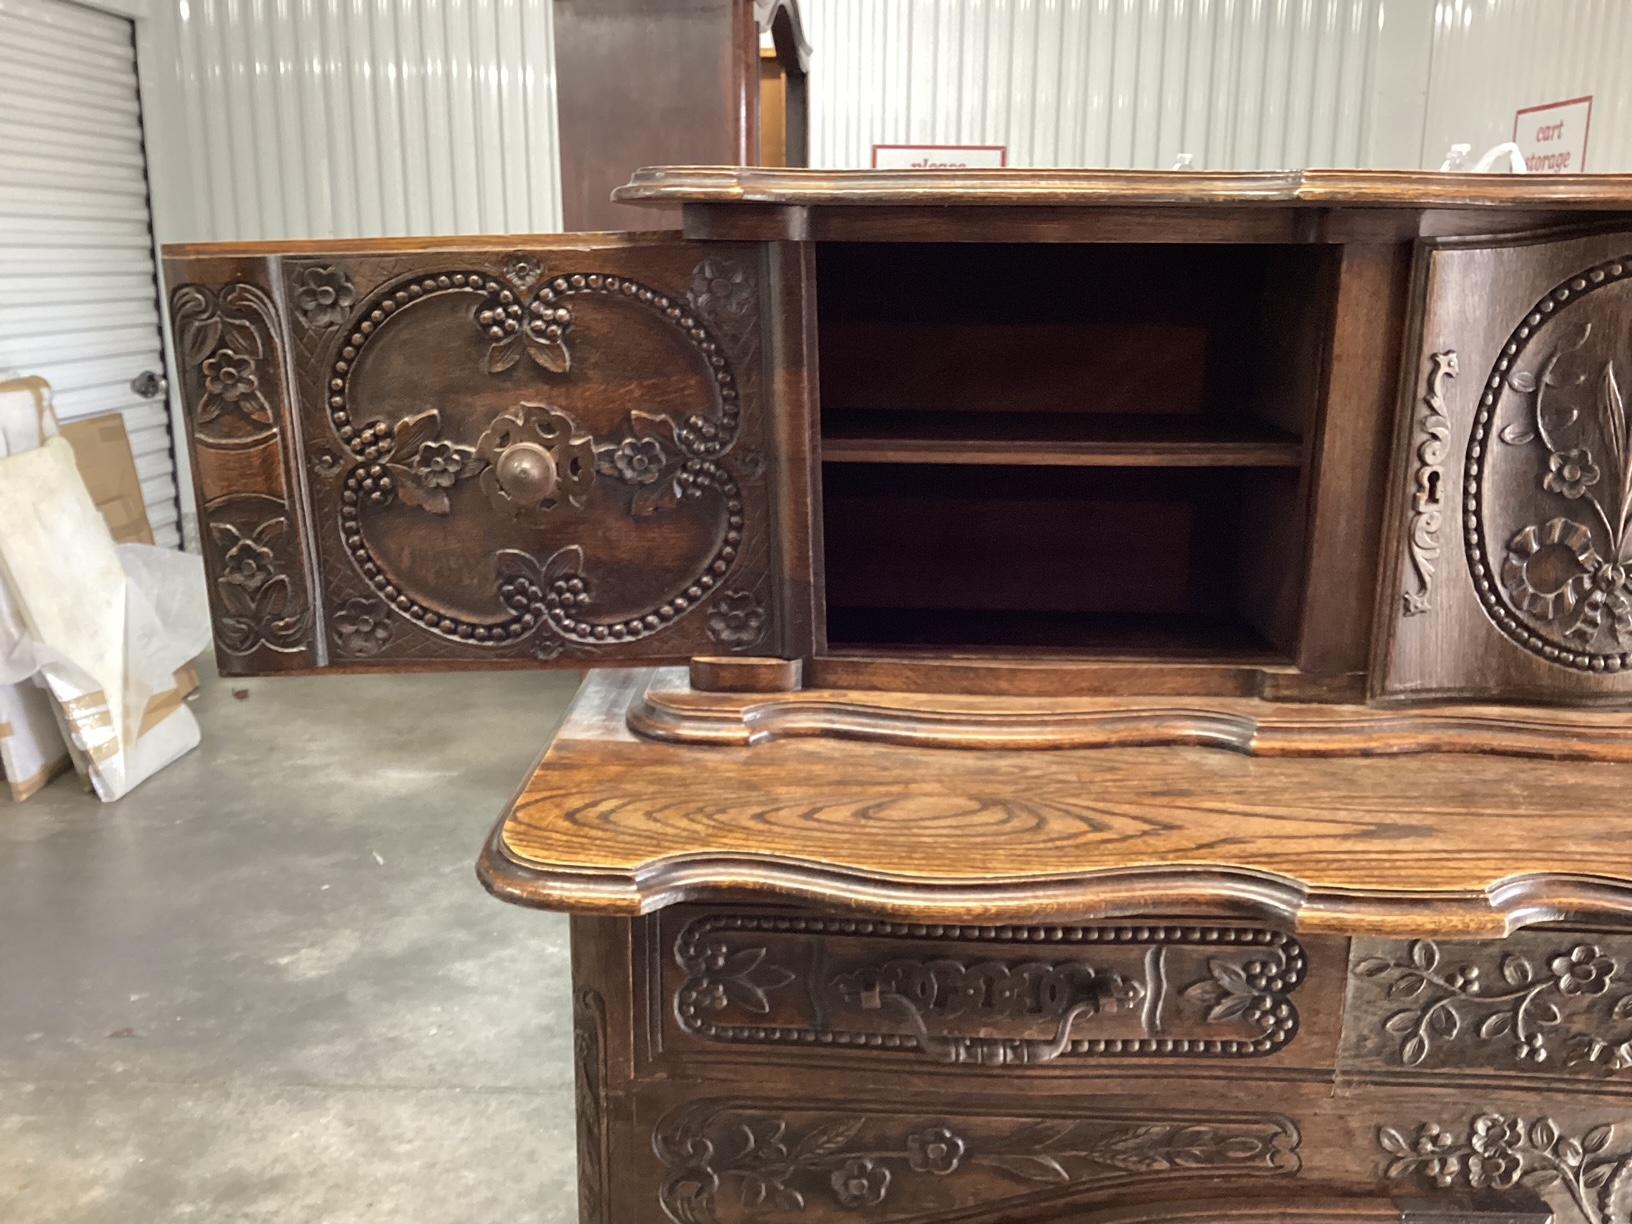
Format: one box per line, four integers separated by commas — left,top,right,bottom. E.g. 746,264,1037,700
70,0,1632,545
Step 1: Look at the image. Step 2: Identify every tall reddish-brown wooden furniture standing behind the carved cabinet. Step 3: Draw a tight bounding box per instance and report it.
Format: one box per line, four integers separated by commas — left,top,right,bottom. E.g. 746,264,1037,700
553,0,809,230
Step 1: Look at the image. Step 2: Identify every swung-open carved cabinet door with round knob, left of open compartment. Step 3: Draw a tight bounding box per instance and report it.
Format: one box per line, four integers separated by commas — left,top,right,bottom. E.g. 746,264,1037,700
165,235,788,674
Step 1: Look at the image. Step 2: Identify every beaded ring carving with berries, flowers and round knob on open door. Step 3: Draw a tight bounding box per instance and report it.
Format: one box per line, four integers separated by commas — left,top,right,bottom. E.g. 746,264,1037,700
328,264,764,659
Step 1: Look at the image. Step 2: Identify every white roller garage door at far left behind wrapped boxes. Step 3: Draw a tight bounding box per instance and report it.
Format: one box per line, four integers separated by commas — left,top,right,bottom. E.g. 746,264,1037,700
0,0,180,545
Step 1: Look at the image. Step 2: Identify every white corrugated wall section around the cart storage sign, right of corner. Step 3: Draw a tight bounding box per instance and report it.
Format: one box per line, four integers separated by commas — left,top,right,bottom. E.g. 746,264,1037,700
1423,0,1632,173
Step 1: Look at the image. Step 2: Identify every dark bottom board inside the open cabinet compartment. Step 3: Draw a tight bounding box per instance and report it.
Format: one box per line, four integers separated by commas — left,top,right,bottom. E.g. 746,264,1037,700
827,607,1278,663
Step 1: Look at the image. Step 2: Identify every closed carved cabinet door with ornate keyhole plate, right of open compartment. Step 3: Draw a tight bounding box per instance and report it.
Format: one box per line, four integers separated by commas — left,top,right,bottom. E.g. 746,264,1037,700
1376,232,1632,702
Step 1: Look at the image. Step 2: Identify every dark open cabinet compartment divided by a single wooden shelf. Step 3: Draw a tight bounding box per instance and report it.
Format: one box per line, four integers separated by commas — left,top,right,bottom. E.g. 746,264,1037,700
818,243,1332,663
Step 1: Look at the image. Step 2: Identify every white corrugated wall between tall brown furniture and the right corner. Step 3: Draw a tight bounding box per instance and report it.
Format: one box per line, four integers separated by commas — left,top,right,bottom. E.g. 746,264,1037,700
801,0,1426,170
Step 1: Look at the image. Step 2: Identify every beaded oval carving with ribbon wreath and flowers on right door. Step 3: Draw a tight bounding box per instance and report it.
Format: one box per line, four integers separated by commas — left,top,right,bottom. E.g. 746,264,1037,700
1467,259,1632,671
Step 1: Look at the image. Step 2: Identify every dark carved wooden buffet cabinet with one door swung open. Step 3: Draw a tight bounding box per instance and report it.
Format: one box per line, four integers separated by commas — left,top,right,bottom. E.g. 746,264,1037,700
166,168,1632,1224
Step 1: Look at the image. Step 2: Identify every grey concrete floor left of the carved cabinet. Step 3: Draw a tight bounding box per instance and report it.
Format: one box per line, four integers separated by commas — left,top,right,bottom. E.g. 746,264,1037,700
0,661,576,1224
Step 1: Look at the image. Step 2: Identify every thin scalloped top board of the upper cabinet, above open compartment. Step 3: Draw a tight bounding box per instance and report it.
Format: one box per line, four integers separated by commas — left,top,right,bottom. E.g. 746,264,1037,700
612,166,1632,211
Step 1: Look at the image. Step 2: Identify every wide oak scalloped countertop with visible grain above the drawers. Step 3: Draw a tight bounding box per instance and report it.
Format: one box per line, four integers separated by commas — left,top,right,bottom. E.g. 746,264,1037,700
480,671,1632,938
